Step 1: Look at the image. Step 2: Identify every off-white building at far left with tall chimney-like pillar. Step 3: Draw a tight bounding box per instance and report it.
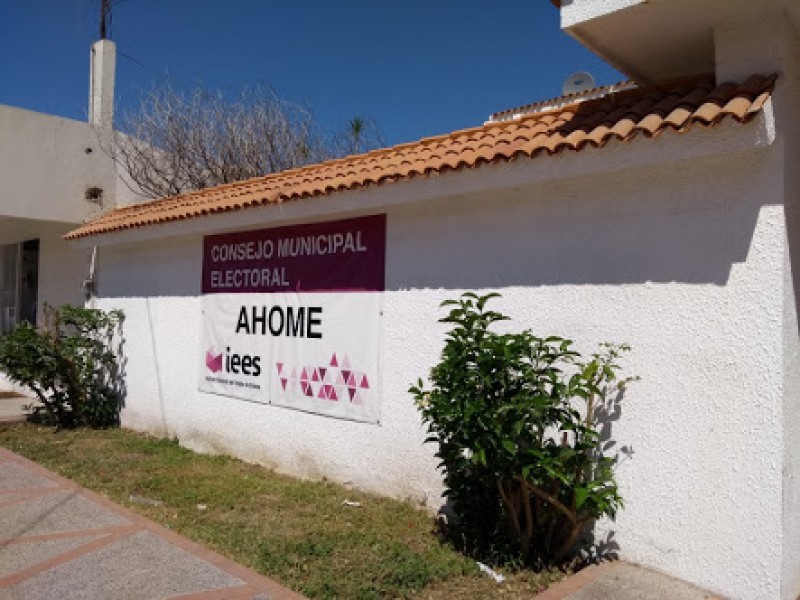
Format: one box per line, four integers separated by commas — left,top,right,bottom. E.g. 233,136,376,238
0,40,132,333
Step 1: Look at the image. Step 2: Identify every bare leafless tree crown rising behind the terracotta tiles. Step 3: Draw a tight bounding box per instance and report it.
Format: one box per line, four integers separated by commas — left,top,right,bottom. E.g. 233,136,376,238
101,86,381,198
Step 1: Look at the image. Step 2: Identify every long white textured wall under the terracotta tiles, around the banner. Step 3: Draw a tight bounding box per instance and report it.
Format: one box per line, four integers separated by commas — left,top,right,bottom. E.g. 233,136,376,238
94,131,785,598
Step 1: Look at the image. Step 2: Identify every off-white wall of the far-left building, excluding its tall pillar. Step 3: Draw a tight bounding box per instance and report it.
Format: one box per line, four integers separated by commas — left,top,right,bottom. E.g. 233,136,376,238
0,105,141,389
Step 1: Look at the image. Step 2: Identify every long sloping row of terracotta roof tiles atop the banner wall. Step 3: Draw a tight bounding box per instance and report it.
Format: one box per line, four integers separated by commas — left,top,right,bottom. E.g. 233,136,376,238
66,75,775,239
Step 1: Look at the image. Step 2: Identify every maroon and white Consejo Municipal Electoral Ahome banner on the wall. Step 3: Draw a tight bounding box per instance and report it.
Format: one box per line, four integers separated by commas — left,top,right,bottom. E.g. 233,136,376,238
200,215,386,422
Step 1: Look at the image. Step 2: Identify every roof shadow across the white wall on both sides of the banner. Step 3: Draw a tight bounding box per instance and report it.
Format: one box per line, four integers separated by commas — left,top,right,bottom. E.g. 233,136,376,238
99,176,762,298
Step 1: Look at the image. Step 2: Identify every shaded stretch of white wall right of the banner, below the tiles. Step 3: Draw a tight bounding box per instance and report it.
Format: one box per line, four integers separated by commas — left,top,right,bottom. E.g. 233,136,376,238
386,175,761,290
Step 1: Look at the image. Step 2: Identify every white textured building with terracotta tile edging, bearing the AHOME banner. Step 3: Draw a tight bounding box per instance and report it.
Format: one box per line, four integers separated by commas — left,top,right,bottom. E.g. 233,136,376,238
68,0,800,599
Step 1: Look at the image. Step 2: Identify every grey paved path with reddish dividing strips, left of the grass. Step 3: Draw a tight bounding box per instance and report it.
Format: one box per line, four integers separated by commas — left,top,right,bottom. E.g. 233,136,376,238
0,448,303,600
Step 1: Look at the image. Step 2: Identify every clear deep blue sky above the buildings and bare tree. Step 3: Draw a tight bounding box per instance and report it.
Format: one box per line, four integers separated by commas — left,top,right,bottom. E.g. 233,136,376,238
0,0,624,144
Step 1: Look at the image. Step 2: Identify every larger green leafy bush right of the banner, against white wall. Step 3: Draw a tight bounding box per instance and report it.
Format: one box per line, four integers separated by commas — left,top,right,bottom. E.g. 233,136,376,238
410,293,629,566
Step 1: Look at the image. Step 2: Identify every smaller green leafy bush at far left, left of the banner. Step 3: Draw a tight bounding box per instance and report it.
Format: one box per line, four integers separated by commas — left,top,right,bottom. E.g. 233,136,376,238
0,305,124,428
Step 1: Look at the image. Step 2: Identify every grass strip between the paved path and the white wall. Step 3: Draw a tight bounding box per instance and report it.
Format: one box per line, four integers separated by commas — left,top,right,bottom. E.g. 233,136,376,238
0,424,562,599
